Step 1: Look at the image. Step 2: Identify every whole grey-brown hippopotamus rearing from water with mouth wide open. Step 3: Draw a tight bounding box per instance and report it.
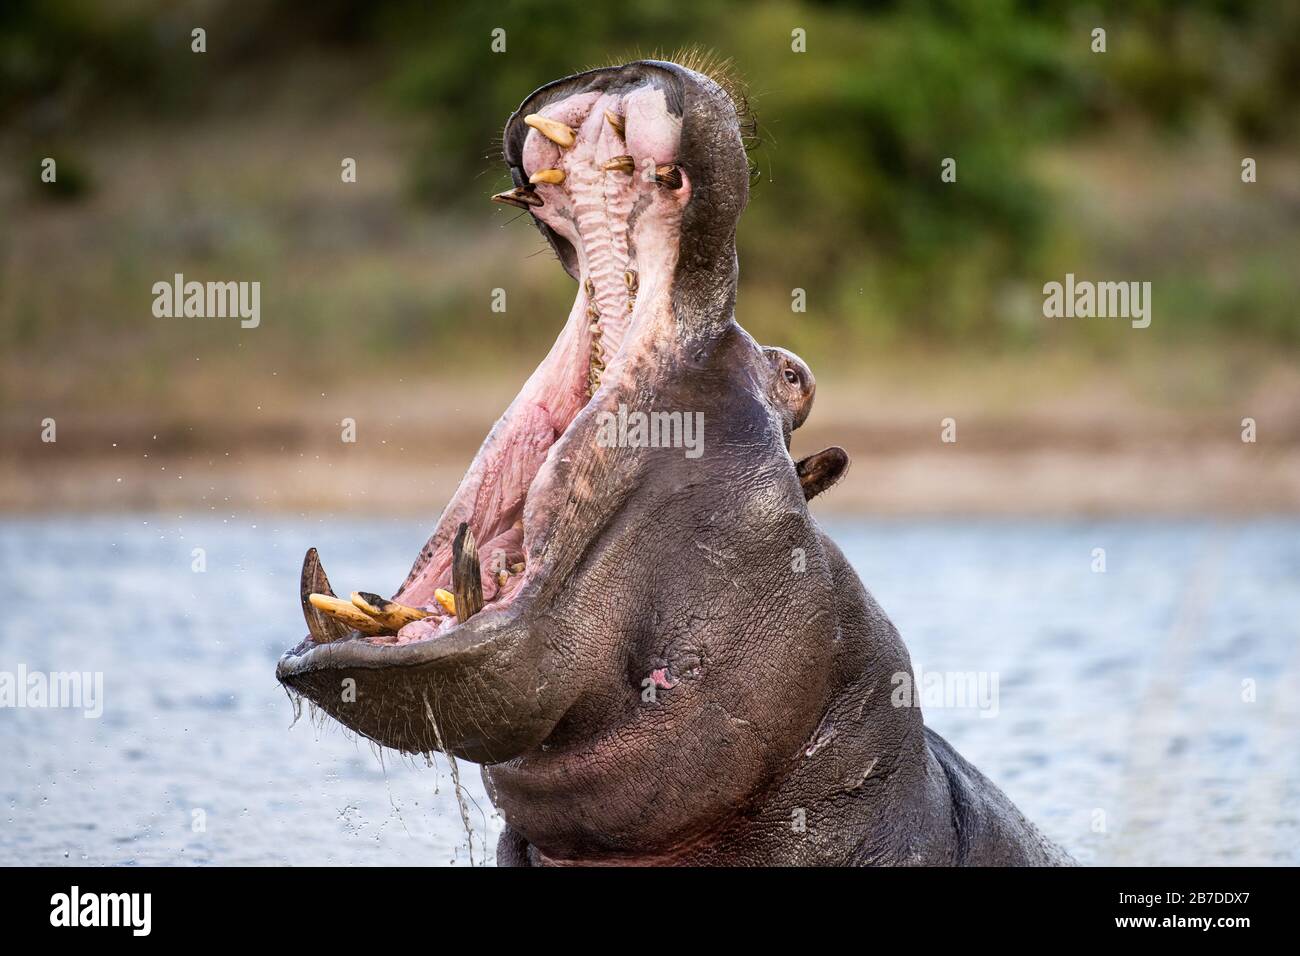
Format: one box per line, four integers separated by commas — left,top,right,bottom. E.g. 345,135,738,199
277,60,1069,865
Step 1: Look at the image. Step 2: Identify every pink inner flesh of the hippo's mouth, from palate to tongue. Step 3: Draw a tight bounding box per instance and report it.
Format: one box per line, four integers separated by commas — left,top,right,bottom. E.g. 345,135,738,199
304,76,690,644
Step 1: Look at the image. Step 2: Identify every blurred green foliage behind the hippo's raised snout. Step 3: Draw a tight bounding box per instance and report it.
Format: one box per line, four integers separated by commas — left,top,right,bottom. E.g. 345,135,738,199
380,0,1296,339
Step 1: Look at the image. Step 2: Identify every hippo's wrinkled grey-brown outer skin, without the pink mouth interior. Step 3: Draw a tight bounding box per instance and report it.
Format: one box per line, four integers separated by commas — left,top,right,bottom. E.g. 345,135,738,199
277,62,1069,865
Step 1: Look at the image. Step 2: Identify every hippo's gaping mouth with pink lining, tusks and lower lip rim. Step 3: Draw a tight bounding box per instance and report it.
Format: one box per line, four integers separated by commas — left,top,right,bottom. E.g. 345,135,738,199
278,62,692,685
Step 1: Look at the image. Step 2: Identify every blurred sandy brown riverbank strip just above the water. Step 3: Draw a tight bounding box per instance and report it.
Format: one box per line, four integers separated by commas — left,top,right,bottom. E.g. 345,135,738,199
0,354,1300,520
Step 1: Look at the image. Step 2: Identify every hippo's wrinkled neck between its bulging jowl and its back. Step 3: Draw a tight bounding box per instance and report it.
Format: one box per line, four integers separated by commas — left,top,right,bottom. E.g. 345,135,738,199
488,536,952,865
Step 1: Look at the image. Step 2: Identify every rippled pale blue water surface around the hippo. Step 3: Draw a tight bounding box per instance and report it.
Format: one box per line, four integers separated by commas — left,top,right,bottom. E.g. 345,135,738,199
0,516,1300,865
